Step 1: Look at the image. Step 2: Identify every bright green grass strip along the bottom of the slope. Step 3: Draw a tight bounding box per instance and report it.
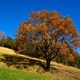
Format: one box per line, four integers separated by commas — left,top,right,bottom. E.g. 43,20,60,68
0,68,64,80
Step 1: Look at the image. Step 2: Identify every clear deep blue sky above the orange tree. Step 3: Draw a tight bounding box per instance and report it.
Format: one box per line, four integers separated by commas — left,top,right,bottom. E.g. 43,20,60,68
0,0,80,52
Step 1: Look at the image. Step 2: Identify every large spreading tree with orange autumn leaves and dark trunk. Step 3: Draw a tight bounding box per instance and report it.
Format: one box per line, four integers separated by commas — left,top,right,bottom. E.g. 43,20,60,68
17,10,80,69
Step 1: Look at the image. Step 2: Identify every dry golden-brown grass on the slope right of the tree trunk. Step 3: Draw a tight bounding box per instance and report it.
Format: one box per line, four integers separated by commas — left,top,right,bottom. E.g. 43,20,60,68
52,62,80,80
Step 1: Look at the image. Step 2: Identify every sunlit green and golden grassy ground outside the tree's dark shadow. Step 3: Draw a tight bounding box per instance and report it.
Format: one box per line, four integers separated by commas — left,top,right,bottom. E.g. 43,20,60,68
0,47,80,80
